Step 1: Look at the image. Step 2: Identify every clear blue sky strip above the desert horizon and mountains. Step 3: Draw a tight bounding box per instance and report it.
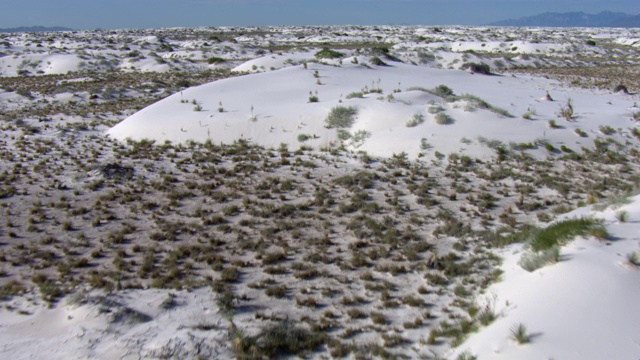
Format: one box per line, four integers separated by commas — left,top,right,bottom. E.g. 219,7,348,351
0,0,640,29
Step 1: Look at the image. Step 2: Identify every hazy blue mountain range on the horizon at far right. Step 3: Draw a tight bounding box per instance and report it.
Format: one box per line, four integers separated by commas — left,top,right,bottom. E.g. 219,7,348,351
489,11,640,27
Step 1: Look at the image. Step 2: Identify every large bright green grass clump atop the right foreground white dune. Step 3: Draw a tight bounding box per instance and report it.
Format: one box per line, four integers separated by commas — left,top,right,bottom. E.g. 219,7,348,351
530,217,608,251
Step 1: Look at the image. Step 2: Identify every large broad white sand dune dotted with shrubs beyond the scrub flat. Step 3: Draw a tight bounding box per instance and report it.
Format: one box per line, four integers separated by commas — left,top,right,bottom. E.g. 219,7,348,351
109,58,633,157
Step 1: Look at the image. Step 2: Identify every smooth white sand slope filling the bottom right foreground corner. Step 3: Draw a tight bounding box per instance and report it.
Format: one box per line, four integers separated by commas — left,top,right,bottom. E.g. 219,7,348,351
451,196,640,360
